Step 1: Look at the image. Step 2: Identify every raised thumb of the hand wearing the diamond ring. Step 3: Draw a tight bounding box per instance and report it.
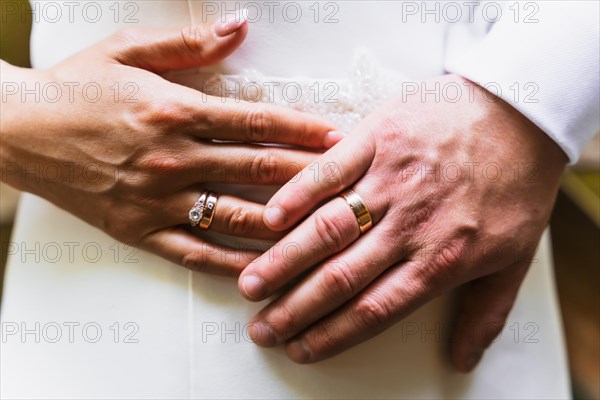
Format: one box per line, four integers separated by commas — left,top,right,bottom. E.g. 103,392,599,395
104,12,248,74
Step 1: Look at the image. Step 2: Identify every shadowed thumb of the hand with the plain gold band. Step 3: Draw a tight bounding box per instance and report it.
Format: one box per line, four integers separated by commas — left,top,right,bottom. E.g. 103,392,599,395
450,262,529,372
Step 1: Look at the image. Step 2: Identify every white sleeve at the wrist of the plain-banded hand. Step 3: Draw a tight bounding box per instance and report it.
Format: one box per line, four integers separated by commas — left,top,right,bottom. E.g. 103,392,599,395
445,1,600,163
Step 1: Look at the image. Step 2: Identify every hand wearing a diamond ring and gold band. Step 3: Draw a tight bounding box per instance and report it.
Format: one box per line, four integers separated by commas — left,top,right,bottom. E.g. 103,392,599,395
1,20,337,274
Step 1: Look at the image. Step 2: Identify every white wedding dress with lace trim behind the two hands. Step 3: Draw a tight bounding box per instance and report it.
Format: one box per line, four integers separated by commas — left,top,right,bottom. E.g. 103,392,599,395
0,1,569,399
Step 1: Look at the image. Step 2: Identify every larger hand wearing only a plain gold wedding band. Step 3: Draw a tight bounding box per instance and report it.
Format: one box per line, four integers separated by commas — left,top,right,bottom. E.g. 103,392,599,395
238,76,566,371
